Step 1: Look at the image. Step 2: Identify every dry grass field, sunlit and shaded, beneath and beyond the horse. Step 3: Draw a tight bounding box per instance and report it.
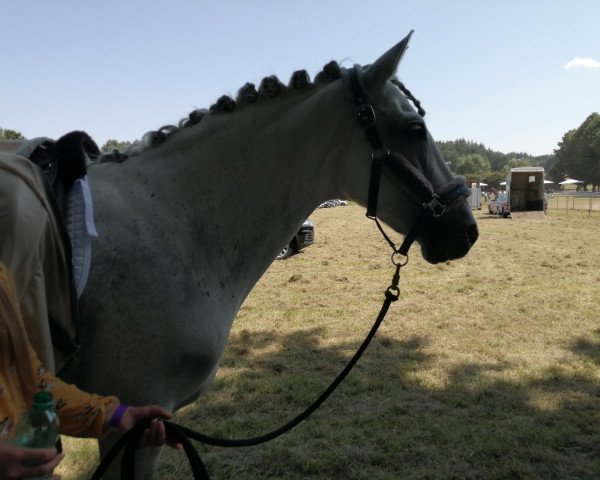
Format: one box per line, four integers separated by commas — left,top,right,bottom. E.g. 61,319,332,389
61,205,600,480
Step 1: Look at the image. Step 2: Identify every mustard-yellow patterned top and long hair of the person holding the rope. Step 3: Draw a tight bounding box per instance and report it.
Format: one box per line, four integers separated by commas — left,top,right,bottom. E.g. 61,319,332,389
0,263,119,441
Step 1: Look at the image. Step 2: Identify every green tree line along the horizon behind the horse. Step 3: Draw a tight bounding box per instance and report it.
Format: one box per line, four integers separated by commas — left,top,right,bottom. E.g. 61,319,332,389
0,112,600,190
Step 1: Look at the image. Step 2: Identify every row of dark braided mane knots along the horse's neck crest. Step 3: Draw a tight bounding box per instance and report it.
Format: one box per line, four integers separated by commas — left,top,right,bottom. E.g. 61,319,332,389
100,60,342,162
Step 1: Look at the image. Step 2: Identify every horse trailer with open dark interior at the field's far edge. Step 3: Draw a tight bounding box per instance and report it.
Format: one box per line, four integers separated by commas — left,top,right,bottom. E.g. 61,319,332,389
506,167,547,217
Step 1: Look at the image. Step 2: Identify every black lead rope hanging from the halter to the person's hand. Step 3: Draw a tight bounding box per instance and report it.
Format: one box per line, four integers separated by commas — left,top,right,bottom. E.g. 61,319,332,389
91,264,406,480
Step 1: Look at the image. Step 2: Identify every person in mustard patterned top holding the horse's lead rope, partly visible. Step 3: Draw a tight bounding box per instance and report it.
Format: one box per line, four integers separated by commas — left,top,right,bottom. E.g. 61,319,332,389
0,263,181,480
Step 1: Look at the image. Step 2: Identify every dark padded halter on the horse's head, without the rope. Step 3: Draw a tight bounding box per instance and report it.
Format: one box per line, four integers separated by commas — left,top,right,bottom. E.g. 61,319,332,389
346,65,469,263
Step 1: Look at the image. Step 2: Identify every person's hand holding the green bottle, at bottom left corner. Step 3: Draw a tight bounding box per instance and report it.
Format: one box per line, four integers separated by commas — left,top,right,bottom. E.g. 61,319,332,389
0,444,64,480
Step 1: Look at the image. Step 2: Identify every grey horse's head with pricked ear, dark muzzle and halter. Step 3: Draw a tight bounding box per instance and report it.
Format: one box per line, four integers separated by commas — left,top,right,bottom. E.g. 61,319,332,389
347,32,478,263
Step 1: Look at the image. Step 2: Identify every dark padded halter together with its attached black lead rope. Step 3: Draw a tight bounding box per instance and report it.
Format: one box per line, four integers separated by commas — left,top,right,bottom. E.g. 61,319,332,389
91,67,468,480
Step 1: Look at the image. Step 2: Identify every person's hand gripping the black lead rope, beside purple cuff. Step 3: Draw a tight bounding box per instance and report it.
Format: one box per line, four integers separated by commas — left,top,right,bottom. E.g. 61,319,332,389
119,405,183,450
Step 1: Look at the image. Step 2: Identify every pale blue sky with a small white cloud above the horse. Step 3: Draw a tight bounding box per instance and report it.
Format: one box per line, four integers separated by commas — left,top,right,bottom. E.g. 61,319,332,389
0,0,600,155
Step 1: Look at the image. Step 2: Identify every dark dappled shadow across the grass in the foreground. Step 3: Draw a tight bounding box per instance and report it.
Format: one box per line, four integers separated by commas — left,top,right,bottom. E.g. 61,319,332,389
159,329,600,480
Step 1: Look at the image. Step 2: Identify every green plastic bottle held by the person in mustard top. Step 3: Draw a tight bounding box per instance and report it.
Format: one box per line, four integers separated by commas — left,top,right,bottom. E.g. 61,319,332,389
12,392,60,480
